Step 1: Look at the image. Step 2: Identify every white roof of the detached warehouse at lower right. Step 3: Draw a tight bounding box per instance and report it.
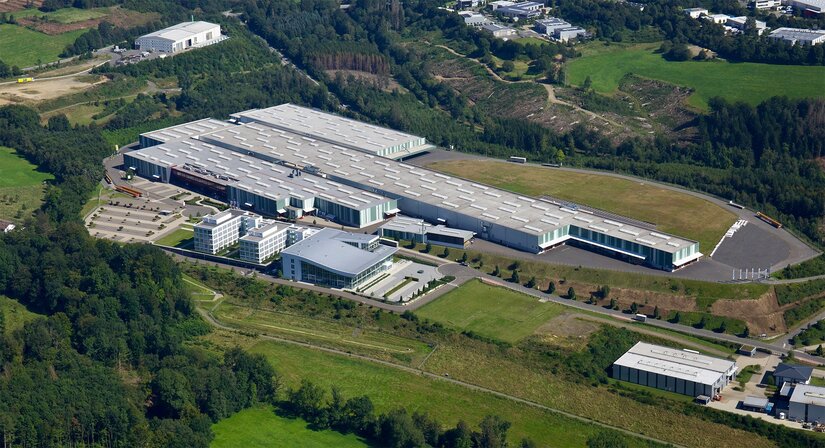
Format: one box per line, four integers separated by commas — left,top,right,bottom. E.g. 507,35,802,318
613,342,736,385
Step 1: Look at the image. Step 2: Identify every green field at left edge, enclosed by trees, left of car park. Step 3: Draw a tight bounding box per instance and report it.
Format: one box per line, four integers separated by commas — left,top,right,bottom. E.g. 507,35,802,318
0,146,52,221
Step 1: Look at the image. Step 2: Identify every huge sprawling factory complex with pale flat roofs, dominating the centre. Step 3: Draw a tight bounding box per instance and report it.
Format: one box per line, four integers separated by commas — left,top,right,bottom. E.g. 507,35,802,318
124,104,702,271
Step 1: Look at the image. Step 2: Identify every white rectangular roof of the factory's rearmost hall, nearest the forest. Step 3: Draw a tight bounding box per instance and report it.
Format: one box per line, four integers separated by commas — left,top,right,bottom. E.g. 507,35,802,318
232,103,426,158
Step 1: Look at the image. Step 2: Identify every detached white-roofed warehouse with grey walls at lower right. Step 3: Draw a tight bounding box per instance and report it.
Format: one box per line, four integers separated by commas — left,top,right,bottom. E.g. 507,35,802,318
612,342,736,397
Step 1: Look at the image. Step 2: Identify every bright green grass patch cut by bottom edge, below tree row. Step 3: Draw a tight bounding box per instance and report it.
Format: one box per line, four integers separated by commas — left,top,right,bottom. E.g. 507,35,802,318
209,407,369,448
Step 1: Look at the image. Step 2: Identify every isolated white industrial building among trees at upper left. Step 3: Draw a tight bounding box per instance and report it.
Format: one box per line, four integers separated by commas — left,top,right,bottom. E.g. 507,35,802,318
135,22,226,53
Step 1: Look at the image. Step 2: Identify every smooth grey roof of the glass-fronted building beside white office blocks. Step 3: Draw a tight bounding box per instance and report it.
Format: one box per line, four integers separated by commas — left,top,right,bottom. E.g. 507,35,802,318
281,228,398,276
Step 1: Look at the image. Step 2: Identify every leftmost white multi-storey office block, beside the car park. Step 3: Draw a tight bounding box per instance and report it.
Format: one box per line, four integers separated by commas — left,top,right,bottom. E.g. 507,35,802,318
194,209,263,255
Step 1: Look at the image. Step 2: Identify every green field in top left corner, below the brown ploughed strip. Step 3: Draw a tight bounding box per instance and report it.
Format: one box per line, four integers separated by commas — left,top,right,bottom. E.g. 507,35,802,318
0,24,86,68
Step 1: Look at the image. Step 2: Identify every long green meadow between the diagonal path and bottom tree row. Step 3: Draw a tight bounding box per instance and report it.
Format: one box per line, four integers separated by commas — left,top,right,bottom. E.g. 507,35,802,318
244,341,645,447
